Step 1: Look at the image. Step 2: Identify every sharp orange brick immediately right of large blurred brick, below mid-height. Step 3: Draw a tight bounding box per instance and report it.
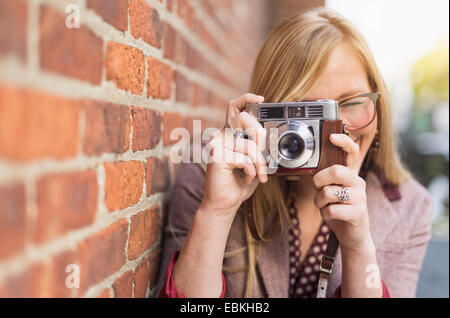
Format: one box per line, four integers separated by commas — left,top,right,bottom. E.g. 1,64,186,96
104,161,144,211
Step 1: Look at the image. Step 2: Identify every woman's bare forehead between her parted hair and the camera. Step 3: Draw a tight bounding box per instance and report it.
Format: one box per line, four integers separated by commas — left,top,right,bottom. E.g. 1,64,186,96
304,43,370,100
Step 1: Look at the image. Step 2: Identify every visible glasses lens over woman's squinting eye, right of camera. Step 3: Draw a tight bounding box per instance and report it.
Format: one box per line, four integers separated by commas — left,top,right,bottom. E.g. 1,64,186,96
339,97,375,128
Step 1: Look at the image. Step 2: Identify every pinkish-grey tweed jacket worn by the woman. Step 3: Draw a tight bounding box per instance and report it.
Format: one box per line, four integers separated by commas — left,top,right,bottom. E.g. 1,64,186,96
157,163,432,298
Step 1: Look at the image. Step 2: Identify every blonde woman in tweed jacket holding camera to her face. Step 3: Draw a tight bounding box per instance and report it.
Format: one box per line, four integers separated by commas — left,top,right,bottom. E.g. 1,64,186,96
159,8,431,297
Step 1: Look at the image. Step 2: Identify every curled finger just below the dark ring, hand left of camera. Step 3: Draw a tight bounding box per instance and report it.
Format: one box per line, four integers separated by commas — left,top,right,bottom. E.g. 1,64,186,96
224,134,268,183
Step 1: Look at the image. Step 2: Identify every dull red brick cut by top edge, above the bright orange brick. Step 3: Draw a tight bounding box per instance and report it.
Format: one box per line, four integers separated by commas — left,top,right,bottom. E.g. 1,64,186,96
87,0,128,31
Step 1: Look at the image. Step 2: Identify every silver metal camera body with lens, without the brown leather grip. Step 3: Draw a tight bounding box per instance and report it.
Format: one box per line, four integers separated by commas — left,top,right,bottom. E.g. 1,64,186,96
246,99,339,173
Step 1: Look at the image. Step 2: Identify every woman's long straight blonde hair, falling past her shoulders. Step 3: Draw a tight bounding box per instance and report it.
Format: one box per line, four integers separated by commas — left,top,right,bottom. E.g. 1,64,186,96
224,8,410,297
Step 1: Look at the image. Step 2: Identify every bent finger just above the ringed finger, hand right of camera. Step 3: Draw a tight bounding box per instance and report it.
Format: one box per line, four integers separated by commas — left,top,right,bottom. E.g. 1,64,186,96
313,165,363,190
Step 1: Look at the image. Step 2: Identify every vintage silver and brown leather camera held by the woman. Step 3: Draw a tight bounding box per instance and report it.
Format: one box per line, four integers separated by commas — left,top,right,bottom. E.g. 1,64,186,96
246,100,345,175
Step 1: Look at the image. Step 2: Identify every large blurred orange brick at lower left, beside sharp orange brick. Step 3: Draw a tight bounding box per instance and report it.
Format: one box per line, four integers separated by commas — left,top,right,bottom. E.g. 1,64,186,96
34,170,98,243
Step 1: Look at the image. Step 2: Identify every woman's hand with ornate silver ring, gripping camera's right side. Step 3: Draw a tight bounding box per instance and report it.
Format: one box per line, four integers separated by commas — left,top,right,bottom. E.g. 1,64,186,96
313,134,373,255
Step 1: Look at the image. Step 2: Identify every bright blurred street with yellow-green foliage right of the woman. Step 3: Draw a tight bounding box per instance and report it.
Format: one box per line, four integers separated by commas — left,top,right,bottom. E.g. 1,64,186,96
326,0,449,297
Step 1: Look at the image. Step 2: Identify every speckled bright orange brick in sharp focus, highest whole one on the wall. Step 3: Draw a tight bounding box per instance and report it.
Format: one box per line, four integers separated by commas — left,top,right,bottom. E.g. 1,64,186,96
105,42,145,95
